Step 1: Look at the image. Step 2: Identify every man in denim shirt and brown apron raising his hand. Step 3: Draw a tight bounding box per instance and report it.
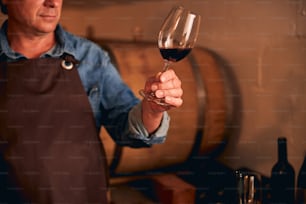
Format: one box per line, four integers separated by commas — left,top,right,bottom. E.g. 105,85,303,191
0,0,183,204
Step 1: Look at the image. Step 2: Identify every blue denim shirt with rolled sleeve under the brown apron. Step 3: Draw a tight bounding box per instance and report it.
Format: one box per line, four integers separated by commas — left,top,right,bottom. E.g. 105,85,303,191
0,21,170,147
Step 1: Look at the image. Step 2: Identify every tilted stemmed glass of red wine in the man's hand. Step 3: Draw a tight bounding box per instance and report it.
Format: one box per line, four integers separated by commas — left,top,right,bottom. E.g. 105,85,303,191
139,6,201,106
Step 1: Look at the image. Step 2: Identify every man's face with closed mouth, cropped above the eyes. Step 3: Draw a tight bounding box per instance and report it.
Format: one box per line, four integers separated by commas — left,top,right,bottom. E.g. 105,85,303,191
2,0,63,35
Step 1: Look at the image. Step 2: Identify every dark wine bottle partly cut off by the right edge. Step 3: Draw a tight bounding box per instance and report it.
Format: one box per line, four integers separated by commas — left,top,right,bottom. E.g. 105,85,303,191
296,152,306,204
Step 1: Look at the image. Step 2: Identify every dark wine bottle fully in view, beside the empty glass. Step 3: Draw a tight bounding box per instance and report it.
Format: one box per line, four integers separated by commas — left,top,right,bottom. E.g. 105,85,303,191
271,137,295,204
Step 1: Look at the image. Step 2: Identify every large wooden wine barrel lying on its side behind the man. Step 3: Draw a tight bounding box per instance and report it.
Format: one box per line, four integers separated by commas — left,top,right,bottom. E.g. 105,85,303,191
100,42,232,174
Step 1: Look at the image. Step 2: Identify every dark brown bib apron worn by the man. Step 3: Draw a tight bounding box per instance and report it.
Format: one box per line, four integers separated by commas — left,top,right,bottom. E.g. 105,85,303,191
0,56,107,204
